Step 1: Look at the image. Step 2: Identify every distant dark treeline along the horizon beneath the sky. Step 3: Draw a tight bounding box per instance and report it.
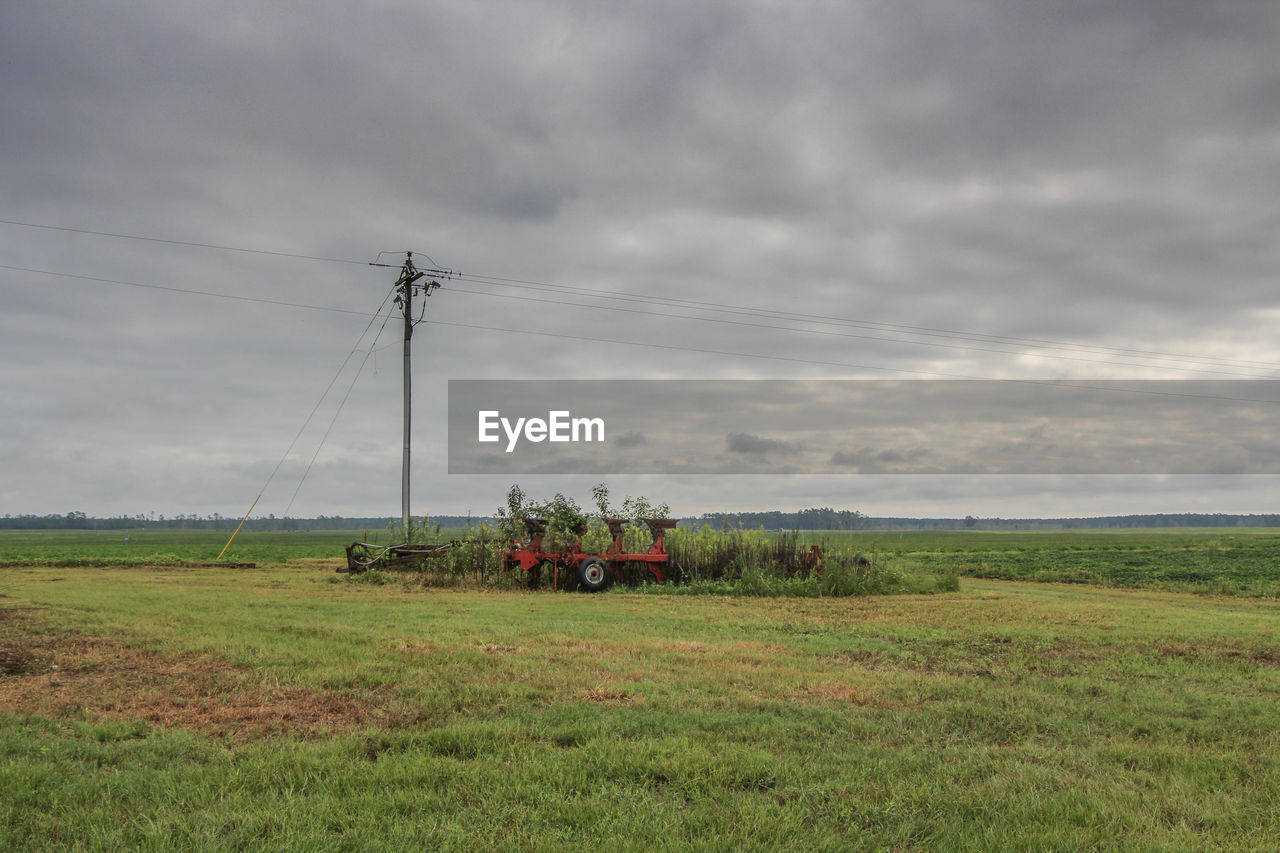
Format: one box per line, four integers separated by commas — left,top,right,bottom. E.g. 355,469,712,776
0,507,1280,530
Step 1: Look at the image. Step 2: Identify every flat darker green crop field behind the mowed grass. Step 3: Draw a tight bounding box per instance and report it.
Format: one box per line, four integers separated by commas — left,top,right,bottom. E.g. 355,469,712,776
0,528,1280,598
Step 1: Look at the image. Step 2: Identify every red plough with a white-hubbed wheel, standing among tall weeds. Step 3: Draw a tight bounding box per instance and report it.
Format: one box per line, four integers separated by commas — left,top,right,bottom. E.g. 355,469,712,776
502,519,676,592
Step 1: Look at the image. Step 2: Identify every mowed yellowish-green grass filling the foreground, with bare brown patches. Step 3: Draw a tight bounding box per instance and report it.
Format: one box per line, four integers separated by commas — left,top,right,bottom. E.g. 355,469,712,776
0,566,1280,850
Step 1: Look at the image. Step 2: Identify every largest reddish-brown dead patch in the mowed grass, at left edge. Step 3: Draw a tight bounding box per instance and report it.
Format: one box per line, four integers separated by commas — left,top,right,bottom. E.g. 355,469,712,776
0,611,394,742
